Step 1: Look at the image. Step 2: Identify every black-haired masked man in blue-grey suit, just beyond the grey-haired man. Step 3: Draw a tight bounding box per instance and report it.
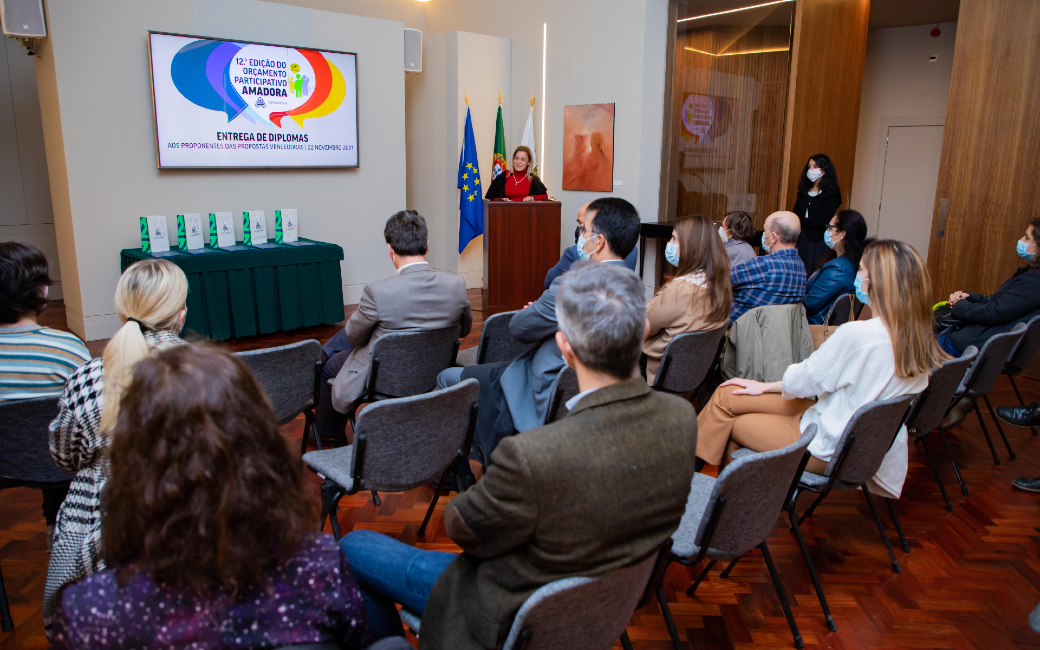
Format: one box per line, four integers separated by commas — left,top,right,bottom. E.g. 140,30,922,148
437,198,640,465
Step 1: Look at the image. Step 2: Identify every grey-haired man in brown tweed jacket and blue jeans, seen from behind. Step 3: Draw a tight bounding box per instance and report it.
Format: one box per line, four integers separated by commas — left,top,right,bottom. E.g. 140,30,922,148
340,261,697,650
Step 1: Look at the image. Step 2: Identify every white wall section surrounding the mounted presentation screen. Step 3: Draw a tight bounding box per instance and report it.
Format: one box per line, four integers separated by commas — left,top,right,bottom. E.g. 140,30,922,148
36,0,407,340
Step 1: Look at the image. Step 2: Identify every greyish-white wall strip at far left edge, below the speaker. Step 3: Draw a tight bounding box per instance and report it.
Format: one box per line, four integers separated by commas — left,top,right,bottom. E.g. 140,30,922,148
0,38,61,300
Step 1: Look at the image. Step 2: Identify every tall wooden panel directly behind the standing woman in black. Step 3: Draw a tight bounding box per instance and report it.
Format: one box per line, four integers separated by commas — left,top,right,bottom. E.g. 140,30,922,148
778,0,869,210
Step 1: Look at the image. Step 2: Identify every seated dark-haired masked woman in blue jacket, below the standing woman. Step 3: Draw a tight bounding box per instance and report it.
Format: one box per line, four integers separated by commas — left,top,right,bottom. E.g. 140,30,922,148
802,210,866,324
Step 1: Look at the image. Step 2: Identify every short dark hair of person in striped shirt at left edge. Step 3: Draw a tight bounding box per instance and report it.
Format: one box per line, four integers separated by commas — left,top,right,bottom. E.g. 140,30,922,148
0,241,53,323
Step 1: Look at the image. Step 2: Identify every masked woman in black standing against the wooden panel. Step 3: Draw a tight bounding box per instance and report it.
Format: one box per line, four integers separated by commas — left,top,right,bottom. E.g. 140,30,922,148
791,154,841,276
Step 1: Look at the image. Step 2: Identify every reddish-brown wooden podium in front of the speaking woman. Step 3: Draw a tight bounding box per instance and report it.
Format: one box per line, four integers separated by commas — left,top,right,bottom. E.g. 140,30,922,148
484,200,560,317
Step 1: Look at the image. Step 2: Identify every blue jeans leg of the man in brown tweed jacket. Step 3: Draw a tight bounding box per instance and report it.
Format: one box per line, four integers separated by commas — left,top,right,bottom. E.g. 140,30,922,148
339,530,457,642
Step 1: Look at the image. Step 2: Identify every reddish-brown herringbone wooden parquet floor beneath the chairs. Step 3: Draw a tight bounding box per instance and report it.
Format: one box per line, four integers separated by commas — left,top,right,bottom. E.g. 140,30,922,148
0,292,1040,650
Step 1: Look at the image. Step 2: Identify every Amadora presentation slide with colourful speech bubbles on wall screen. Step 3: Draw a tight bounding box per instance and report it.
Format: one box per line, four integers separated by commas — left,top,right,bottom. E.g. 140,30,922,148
149,32,358,167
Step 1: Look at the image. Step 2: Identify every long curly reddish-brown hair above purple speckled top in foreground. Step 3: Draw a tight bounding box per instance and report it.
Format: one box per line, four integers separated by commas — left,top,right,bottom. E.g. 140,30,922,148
103,344,314,598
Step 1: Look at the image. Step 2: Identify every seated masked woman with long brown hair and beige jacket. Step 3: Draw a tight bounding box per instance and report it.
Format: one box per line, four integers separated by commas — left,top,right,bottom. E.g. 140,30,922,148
643,214,733,386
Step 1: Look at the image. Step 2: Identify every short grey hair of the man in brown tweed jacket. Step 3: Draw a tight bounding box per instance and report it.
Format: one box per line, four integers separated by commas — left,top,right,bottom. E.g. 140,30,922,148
556,262,647,380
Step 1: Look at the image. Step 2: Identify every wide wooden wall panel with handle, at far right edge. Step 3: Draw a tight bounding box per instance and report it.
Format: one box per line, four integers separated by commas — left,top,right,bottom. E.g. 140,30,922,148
928,0,1040,376
